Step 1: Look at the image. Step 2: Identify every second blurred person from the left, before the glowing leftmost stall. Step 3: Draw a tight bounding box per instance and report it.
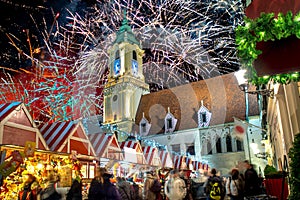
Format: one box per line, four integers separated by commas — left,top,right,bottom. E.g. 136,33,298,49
40,173,61,200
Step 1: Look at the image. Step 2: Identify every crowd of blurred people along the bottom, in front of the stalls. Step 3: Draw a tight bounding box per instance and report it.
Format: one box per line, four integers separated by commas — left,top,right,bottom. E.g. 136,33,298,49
18,161,261,200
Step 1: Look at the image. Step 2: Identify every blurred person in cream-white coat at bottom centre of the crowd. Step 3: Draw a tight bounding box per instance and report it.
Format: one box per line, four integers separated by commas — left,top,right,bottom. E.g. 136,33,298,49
165,170,186,200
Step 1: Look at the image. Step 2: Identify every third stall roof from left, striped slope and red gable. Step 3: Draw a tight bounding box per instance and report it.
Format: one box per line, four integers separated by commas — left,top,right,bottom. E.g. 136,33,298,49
88,133,123,160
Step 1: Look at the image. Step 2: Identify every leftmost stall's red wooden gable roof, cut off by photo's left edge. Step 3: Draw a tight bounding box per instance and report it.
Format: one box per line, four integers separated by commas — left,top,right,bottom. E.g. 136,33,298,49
0,102,49,150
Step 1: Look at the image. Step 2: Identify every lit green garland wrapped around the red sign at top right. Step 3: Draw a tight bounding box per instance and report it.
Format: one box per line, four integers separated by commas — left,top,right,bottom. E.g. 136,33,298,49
235,11,300,85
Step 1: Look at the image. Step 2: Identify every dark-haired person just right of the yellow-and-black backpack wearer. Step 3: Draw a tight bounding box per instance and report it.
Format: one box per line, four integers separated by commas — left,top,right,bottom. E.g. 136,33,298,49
226,169,244,200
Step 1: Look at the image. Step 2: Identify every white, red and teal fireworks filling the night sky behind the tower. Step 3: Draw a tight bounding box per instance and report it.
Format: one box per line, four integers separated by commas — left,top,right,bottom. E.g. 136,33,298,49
0,0,244,121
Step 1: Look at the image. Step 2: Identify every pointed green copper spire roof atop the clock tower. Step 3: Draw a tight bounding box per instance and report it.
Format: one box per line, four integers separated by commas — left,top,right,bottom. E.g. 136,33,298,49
114,11,140,45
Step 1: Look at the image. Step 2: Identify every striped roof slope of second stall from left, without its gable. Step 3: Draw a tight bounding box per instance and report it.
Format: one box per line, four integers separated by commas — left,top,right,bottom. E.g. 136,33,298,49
39,121,76,151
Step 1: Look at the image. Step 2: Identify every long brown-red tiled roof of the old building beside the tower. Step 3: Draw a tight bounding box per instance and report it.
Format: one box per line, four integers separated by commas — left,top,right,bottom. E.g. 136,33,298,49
135,73,259,135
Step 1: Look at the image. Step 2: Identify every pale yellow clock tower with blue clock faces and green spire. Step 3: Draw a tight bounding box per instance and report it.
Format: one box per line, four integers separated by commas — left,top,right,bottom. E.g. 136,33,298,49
103,12,149,141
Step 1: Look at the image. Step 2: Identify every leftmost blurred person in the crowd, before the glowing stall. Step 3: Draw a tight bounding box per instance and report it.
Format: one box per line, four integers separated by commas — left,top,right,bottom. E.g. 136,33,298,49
18,174,39,200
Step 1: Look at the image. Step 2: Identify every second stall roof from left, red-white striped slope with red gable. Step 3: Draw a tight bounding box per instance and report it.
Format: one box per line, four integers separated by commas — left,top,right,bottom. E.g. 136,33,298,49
40,121,96,156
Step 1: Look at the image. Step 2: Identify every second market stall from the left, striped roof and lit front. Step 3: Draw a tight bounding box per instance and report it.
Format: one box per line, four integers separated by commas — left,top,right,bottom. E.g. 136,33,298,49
39,121,97,179
